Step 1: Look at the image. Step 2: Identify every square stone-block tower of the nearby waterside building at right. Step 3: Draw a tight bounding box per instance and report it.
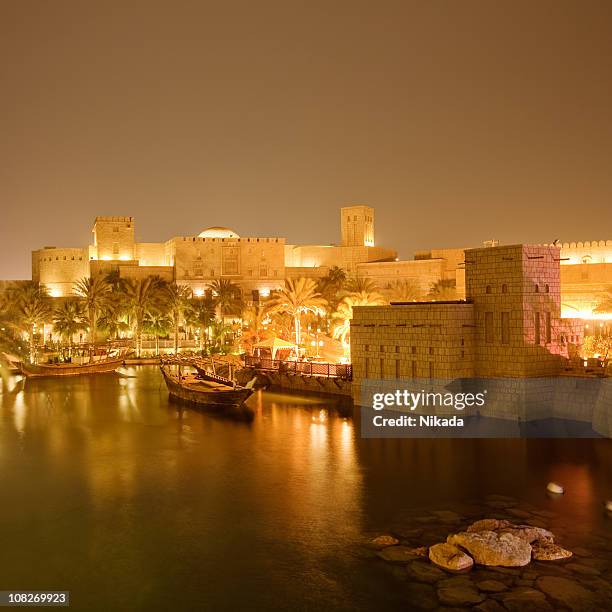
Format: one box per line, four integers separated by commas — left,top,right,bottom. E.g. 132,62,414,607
466,245,563,377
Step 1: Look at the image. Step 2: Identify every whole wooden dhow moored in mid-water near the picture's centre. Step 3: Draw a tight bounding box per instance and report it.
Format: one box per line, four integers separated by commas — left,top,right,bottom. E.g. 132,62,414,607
160,359,255,420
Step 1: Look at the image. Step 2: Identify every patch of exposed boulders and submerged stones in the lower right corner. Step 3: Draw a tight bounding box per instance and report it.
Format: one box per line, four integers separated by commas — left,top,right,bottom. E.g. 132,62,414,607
367,495,612,612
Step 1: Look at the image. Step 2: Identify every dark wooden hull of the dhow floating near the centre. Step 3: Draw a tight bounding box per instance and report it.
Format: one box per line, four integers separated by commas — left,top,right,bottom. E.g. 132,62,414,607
161,368,253,420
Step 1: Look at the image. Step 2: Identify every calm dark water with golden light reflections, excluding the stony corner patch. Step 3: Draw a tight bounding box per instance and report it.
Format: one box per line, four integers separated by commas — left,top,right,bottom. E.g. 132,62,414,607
0,367,612,610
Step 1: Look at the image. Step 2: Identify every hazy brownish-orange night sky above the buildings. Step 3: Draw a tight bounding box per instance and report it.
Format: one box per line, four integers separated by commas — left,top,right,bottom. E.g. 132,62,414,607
0,0,612,279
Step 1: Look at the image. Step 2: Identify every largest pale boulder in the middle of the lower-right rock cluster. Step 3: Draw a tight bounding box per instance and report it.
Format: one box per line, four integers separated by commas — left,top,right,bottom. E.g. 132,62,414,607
446,531,531,567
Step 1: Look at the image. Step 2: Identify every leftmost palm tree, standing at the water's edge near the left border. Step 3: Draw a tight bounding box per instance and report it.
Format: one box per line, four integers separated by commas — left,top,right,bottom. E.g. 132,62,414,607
8,281,51,363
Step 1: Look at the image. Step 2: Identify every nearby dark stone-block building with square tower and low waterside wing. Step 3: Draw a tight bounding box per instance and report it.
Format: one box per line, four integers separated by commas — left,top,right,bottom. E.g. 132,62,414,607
351,245,583,406
